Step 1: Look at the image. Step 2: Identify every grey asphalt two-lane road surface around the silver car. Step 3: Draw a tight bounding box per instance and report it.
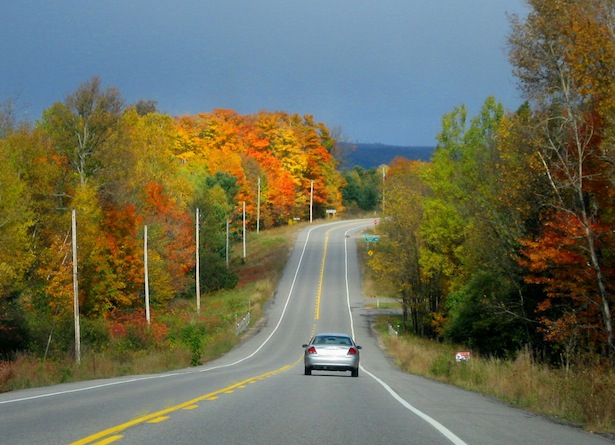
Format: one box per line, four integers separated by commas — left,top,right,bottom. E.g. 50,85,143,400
0,220,613,445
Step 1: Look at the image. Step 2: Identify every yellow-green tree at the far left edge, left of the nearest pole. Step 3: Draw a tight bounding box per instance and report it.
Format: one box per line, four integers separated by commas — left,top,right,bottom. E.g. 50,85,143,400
0,123,73,354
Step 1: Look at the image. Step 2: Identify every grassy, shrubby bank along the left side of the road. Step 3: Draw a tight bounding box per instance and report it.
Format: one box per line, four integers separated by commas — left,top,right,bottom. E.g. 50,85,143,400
0,223,298,392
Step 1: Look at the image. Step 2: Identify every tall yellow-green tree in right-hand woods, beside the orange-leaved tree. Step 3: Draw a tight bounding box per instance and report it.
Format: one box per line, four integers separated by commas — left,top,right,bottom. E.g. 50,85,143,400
421,98,531,354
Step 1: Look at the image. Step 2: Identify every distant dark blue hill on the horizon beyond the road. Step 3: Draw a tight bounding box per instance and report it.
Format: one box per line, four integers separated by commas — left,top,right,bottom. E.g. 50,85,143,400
337,142,435,169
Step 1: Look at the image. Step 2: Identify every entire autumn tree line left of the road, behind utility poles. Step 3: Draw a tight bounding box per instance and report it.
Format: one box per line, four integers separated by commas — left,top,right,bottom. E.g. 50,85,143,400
0,77,343,355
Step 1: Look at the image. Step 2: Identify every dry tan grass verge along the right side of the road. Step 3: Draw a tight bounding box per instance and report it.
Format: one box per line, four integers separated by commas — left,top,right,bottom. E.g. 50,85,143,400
380,329,615,434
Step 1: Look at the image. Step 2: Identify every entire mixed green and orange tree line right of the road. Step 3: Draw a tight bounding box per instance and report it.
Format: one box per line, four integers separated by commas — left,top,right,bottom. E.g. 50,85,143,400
370,0,615,366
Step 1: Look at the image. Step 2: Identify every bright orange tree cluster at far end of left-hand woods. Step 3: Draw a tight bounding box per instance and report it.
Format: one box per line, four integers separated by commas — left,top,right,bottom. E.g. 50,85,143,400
175,109,343,226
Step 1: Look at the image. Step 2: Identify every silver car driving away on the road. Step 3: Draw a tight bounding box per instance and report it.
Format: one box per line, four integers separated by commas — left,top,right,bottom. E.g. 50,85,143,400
303,333,361,377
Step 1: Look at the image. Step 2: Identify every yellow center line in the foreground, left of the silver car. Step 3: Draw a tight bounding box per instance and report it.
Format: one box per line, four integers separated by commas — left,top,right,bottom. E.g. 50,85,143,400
70,363,296,445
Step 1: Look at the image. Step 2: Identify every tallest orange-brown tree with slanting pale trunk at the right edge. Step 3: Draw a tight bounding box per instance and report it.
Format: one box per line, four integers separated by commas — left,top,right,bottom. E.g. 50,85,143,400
510,0,615,361
